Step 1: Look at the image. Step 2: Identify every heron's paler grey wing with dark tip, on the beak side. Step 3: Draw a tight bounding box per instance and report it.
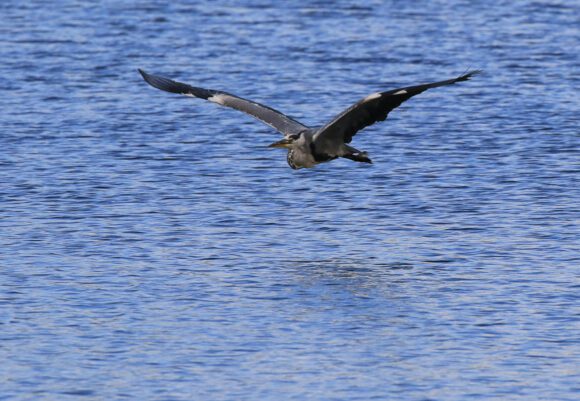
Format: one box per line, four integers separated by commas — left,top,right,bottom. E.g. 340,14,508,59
139,69,308,135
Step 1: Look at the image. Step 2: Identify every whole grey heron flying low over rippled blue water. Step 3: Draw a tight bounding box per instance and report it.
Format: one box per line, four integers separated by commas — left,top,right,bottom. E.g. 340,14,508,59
139,69,481,169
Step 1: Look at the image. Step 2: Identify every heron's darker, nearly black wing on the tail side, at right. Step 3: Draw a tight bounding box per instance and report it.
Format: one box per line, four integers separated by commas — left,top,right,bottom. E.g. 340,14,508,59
314,70,481,143
